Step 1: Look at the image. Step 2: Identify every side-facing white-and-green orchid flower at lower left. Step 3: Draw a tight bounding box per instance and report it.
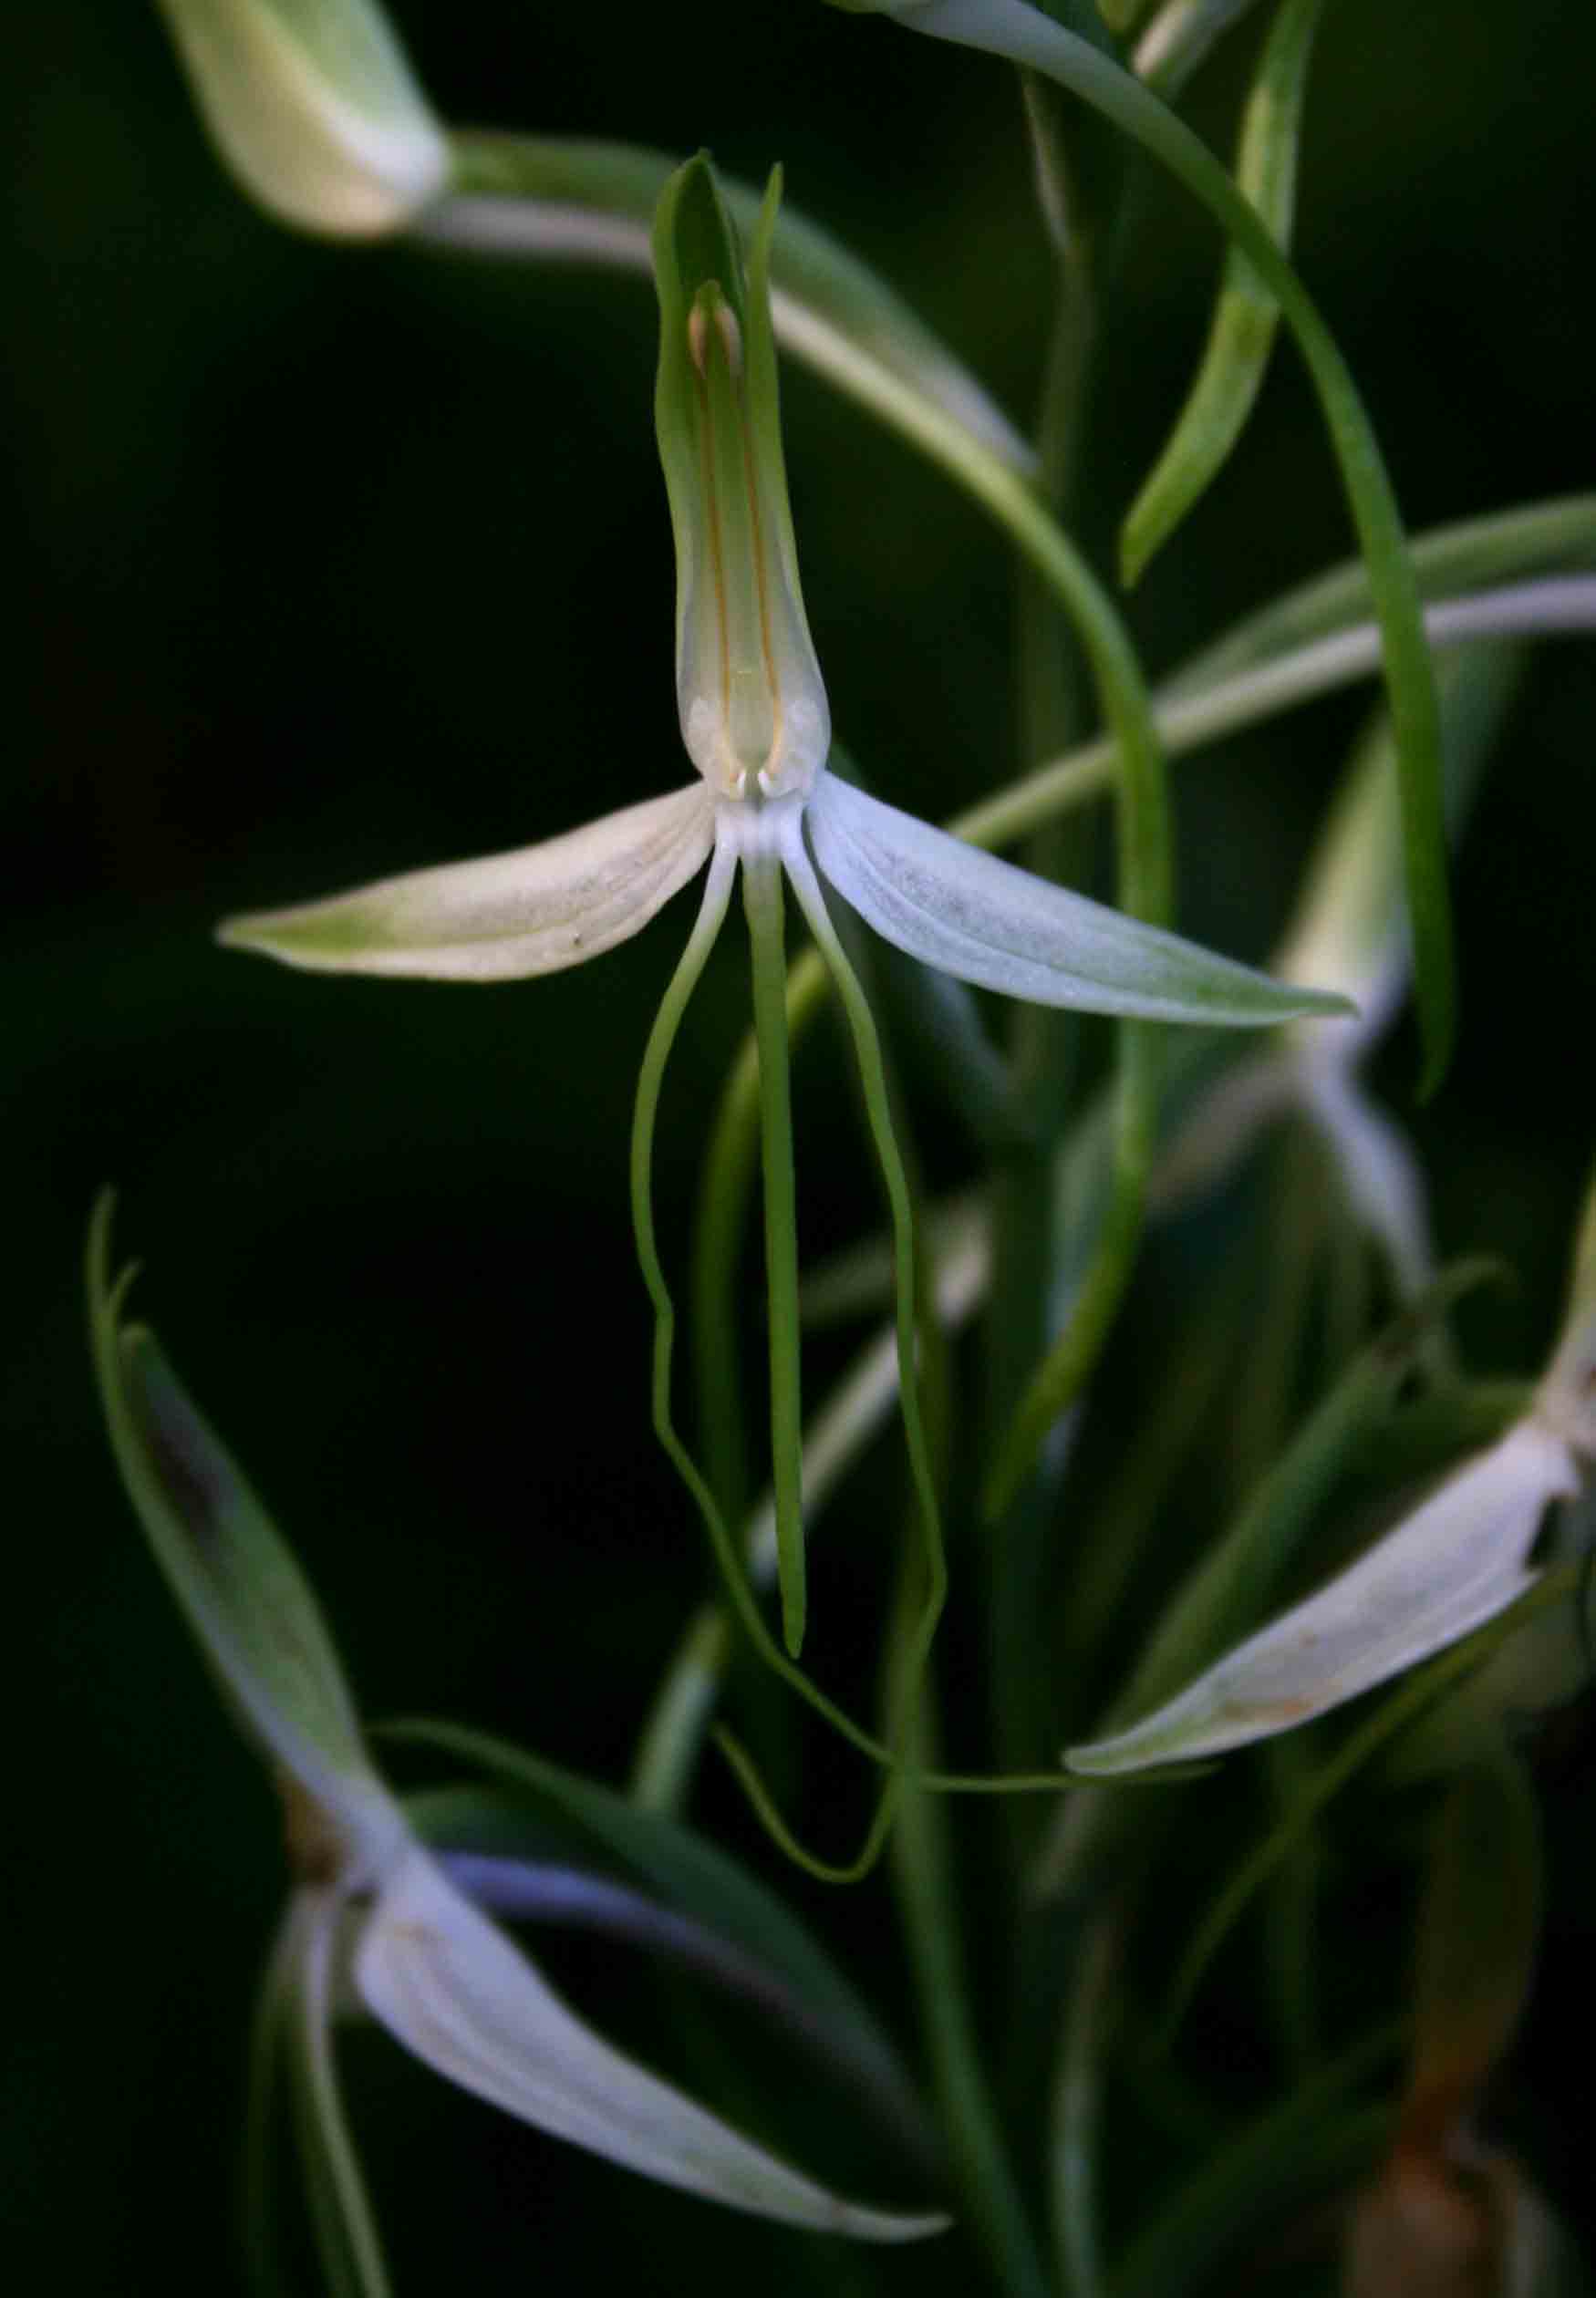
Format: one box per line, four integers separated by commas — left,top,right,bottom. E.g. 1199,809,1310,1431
89,1199,948,2298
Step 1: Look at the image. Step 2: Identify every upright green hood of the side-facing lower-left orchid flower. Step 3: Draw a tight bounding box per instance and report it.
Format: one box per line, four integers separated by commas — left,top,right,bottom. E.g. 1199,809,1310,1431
88,1195,387,1808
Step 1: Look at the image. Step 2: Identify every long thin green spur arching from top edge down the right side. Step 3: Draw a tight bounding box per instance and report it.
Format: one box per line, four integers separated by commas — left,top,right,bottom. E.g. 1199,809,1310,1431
865,0,1456,1092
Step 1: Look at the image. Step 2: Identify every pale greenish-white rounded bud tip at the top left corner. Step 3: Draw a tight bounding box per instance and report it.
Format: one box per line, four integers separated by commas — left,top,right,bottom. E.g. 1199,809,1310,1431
161,0,449,239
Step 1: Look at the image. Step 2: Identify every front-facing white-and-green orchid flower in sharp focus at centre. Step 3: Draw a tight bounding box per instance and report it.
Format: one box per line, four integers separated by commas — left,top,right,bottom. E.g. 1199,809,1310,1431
221,156,1345,1652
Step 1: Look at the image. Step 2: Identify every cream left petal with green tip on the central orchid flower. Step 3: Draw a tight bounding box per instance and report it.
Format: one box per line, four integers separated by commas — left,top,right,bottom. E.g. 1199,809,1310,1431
219,782,715,981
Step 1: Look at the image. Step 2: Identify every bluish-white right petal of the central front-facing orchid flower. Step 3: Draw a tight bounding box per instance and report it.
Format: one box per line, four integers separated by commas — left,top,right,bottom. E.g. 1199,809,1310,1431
807,774,1348,1027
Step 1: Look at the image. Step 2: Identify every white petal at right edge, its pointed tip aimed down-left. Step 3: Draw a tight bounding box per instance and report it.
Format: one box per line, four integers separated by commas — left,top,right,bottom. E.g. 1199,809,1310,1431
1065,1420,1578,1776
